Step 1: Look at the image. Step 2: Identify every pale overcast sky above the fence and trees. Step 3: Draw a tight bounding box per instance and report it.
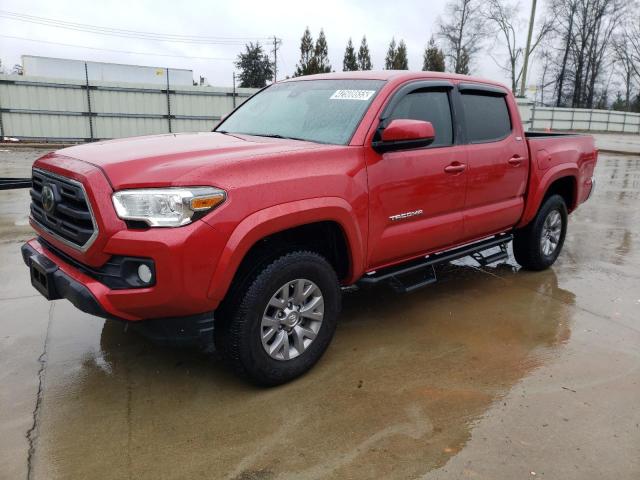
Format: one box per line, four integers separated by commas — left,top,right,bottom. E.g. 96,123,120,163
0,0,542,86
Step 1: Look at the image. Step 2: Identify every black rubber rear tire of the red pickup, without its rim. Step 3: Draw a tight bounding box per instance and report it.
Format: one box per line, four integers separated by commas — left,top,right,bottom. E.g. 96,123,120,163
513,195,568,270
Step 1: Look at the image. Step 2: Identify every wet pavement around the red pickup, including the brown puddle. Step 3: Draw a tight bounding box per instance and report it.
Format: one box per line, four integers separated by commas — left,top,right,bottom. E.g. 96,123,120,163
0,147,640,480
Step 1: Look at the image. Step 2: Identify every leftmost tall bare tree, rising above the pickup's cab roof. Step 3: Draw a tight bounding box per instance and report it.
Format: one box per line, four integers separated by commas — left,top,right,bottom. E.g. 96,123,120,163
438,0,487,74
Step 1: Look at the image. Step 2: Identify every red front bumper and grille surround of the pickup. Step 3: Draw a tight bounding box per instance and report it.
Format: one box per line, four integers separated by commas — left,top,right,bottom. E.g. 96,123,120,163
25,158,228,322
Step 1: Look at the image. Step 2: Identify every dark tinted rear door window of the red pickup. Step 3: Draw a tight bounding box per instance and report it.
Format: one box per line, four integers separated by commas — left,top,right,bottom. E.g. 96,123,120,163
462,92,511,143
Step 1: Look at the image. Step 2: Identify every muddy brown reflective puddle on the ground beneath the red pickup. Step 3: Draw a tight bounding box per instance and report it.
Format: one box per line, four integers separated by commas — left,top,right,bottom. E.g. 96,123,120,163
41,267,572,478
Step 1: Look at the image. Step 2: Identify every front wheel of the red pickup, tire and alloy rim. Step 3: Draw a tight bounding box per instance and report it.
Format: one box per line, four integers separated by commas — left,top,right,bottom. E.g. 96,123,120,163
216,251,340,386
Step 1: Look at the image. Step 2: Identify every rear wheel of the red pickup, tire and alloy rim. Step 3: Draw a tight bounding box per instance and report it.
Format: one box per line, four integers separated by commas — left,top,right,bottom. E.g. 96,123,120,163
513,195,568,270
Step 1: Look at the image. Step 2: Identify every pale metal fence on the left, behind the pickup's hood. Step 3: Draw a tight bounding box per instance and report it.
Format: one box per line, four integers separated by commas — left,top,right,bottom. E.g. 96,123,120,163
0,75,255,141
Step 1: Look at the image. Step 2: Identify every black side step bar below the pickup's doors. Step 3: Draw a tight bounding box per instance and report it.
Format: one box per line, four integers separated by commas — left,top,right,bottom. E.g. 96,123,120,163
358,234,513,293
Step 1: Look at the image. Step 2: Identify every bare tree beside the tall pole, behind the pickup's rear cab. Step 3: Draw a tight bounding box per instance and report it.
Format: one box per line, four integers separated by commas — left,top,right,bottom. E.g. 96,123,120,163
485,0,551,96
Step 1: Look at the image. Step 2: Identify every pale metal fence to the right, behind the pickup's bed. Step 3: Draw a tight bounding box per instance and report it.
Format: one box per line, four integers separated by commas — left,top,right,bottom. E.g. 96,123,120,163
518,100,640,134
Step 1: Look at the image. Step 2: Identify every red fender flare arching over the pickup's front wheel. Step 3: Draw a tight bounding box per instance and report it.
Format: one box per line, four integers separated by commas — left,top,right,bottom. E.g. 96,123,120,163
208,197,365,302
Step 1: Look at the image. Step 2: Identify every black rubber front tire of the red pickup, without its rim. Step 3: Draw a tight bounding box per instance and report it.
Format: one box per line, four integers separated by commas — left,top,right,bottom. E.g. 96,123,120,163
214,251,341,386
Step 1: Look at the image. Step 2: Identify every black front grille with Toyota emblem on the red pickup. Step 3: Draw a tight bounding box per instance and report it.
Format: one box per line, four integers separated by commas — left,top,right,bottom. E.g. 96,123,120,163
31,168,98,251
